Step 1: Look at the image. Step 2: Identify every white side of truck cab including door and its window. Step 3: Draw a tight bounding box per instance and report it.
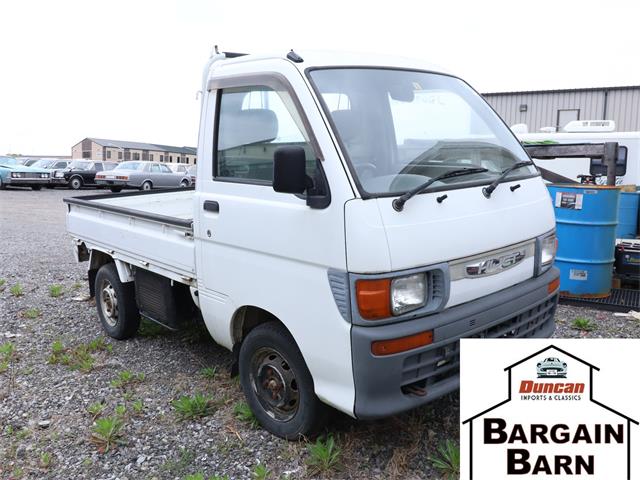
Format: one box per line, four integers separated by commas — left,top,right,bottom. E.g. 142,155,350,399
195,62,352,412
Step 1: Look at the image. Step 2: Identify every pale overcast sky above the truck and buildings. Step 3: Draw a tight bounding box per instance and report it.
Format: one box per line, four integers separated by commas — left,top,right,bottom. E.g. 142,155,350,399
0,0,640,155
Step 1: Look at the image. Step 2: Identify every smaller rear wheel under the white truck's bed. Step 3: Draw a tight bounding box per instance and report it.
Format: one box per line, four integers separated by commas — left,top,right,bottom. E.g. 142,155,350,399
95,263,140,340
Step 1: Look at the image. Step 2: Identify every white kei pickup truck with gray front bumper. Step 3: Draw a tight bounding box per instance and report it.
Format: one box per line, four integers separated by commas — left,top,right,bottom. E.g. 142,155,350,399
64,51,559,439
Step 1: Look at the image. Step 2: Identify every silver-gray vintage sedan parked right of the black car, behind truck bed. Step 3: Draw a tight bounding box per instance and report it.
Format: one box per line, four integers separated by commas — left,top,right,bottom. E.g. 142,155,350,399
96,161,191,192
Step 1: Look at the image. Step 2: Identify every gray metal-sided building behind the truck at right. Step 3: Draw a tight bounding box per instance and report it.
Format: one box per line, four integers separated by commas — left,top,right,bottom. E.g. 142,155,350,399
483,86,640,133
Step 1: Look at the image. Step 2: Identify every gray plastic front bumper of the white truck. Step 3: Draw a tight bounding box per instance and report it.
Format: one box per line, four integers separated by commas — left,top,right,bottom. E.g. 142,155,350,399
351,267,560,419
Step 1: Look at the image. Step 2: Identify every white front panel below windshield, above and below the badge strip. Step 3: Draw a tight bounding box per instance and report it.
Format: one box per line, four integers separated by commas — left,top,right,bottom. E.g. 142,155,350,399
345,177,555,305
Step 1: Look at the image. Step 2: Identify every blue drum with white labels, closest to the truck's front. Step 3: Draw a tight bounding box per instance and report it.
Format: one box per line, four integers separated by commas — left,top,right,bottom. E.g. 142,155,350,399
547,184,620,297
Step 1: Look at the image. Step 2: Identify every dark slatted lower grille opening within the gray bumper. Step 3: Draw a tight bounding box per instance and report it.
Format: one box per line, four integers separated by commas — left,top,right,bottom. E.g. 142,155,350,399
401,296,557,393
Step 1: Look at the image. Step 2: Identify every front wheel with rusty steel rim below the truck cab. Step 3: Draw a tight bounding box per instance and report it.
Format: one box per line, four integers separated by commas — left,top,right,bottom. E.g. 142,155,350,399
239,322,326,440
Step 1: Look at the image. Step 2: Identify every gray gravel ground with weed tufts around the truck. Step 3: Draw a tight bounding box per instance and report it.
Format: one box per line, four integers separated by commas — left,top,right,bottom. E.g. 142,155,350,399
0,189,640,479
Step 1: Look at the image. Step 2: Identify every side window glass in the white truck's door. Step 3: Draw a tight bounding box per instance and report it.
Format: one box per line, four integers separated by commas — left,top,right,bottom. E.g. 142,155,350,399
214,86,316,185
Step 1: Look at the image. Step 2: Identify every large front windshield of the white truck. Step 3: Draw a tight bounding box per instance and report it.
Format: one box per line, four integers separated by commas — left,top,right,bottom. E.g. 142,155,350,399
310,68,537,196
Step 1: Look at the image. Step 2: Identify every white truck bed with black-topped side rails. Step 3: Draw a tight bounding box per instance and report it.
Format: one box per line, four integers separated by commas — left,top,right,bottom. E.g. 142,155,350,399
64,189,196,285
